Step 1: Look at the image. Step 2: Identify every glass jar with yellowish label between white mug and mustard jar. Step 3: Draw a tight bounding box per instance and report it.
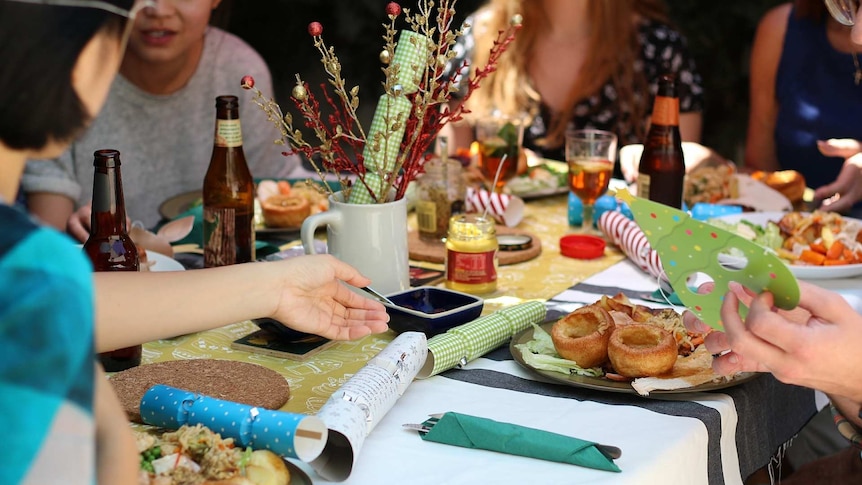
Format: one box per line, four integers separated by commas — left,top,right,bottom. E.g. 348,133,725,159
416,158,466,242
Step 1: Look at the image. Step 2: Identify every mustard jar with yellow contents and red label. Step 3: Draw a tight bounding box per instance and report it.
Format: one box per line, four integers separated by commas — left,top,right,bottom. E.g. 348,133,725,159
446,214,499,294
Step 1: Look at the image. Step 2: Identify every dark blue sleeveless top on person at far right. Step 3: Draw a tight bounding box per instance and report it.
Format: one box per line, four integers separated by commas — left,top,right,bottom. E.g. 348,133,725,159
775,10,862,189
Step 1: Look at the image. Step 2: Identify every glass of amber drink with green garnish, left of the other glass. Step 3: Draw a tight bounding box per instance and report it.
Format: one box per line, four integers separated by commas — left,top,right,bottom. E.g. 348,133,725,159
476,115,525,193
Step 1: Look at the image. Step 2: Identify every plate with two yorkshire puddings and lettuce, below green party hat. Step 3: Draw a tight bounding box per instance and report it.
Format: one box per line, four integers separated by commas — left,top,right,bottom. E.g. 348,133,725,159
510,294,758,396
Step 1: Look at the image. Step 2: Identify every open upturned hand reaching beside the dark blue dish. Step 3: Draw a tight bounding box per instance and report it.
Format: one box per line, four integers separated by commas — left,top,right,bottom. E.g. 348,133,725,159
267,255,389,340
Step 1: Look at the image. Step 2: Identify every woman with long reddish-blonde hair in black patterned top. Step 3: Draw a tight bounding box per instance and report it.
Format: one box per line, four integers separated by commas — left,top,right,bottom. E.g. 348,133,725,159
442,0,703,160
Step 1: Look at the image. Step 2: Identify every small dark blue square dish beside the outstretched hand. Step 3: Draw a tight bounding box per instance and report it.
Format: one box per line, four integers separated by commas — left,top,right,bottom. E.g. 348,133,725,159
383,286,485,337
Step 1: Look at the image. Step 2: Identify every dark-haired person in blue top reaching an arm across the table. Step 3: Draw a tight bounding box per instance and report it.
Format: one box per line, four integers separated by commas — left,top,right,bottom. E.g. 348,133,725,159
0,0,388,485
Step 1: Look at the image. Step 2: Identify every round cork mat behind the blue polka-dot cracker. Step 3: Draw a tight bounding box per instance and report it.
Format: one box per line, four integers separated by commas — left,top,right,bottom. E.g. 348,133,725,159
109,359,290,423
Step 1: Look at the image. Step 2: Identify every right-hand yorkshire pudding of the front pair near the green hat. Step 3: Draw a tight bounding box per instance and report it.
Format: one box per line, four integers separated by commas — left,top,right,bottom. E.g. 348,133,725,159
608,323,677,377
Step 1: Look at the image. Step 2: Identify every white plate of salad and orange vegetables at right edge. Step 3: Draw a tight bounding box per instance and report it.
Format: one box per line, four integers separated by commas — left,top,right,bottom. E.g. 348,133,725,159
716,212,862,280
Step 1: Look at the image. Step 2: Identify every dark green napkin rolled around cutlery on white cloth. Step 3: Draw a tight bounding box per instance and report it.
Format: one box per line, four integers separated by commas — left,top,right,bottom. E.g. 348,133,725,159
419,412,620,472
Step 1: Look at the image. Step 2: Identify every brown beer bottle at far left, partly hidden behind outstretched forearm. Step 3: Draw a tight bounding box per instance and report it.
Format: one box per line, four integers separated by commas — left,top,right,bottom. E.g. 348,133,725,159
84,150,142,372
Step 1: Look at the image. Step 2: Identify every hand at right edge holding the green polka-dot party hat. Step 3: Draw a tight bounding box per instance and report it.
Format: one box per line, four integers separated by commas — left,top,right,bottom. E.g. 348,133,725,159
706,281,862,402
